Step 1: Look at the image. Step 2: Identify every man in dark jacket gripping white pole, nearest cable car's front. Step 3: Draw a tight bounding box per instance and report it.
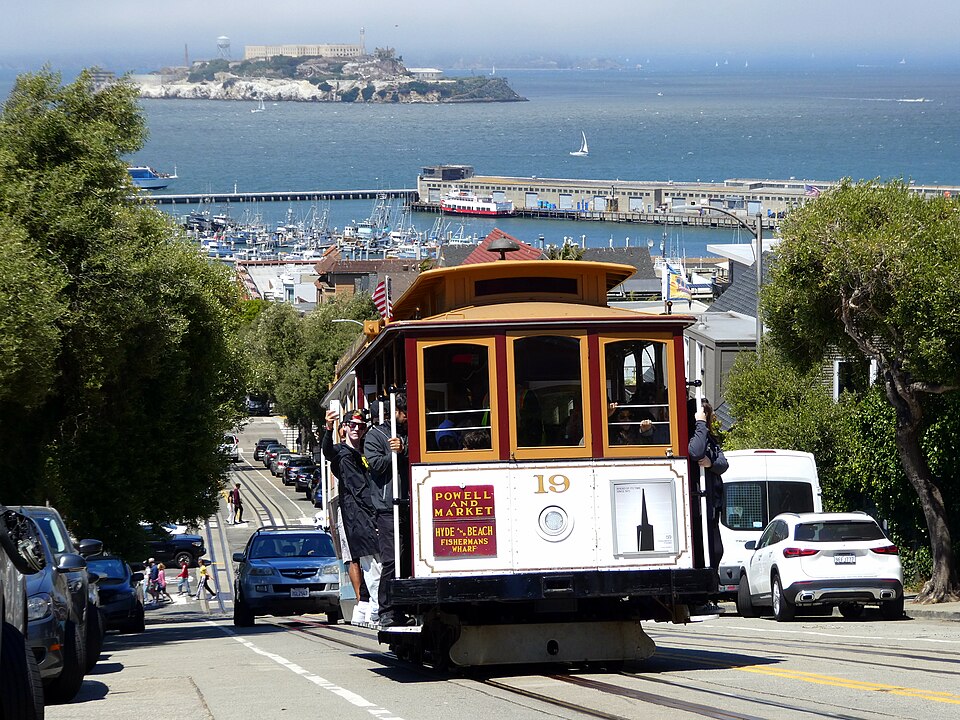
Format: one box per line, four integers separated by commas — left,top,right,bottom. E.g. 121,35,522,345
363,393,410,627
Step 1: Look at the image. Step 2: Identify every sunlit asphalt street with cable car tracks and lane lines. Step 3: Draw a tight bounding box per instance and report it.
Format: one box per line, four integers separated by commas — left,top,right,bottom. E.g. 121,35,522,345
47,419,960,720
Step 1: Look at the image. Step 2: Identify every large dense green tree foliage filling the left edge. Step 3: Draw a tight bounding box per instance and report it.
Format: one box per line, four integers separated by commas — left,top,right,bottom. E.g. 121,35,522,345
0,71,245,551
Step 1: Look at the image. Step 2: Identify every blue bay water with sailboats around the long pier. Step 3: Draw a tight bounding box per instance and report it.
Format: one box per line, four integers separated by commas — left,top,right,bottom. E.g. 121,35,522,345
7,65,960,257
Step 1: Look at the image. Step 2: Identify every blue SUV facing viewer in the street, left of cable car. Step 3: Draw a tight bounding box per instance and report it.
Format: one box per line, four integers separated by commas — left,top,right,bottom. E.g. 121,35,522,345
233,525,341,627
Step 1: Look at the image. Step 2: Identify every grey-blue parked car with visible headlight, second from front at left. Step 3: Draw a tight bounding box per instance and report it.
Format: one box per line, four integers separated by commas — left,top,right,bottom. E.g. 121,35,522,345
27,519,90,703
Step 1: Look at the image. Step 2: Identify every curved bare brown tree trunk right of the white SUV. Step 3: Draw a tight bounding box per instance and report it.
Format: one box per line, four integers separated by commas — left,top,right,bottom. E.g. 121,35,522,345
897,412,960,603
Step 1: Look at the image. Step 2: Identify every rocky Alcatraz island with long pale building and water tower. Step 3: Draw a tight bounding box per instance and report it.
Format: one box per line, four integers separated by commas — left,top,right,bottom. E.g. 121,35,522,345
131,30,526,103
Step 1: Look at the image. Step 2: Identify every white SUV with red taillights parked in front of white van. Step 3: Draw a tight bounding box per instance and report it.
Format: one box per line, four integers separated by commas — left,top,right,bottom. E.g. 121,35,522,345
737,512,903,621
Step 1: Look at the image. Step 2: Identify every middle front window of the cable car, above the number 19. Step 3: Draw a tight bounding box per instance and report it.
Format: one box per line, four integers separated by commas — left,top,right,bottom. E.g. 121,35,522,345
513,335,583,447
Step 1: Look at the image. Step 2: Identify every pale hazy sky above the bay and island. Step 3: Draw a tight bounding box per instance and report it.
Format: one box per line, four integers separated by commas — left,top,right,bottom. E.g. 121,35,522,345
0,0,960,72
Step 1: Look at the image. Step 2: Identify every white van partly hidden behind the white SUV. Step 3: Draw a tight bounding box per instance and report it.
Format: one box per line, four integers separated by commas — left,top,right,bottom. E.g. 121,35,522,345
719,450,823,597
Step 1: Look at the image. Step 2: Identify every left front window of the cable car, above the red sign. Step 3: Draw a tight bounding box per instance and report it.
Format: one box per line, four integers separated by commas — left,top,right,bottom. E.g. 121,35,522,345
423,343,492,451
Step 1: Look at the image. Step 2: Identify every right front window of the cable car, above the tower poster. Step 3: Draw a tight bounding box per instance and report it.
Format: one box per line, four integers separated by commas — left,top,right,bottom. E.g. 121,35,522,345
604,340,670,446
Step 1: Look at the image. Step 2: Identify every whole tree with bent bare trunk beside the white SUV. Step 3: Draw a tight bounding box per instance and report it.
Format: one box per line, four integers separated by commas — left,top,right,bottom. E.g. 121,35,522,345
762,180,960,602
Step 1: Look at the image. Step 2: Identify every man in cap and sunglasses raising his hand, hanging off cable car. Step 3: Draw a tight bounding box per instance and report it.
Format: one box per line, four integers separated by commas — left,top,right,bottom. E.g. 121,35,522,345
321,408,380,623
